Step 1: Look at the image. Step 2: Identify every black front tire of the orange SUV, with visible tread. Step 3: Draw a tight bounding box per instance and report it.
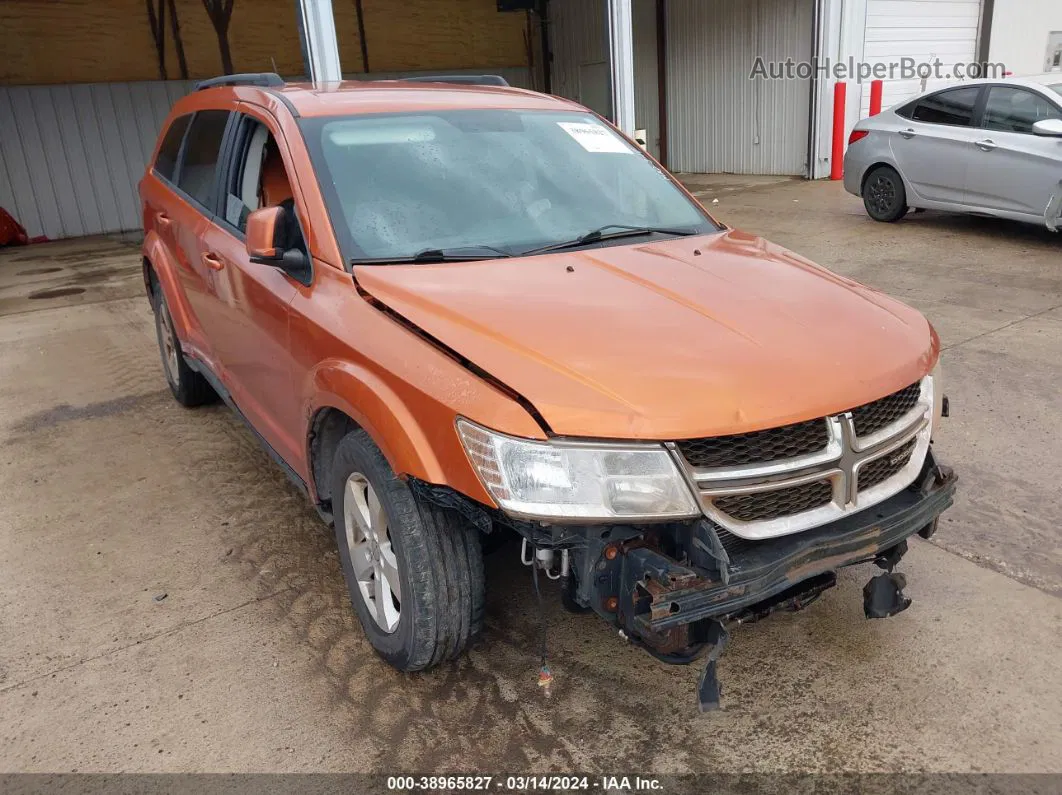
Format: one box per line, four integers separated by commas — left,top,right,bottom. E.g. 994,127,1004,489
331,430,485,671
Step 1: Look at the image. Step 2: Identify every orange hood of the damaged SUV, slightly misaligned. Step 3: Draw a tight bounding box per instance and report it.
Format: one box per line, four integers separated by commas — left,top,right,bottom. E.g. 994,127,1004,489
354,231,939,439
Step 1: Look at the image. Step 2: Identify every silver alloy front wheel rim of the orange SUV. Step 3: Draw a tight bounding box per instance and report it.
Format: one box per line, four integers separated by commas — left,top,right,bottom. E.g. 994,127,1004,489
343,472,401,633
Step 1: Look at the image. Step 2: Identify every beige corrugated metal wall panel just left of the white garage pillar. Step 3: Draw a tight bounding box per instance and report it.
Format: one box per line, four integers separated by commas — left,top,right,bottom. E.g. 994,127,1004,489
667,0,813,174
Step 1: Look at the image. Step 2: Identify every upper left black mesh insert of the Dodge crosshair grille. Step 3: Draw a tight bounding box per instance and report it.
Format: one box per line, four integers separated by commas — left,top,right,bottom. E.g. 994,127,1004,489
675,419,828,467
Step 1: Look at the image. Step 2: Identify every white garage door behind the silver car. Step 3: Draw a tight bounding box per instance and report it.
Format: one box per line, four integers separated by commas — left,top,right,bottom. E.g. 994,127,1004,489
860,0,981,118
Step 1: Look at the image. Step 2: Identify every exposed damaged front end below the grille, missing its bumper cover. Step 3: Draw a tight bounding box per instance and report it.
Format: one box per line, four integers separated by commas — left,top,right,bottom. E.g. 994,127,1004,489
422,451,957,711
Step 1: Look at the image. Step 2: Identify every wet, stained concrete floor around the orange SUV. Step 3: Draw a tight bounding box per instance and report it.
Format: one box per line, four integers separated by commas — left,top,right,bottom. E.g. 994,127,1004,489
0,178,1062,774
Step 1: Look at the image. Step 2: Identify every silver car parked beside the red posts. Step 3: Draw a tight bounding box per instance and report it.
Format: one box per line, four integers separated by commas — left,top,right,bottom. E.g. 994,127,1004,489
844,73,1062,230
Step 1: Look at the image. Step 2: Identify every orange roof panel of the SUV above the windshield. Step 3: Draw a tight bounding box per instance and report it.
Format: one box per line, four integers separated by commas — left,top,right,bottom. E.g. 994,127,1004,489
268,80,578,116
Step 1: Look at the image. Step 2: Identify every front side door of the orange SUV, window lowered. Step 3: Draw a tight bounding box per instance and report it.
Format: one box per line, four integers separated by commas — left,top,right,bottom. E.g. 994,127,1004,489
201,105,305,463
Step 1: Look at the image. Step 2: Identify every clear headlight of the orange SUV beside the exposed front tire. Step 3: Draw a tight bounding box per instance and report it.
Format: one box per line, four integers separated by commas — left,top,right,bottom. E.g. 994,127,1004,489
458,419,701,520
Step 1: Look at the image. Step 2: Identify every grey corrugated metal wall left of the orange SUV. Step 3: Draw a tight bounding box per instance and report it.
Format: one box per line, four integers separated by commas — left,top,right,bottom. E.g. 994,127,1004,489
0,81,192,243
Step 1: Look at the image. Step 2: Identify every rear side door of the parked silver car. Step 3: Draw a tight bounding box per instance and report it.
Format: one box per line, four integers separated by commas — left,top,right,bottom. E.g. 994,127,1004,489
891,86,982,205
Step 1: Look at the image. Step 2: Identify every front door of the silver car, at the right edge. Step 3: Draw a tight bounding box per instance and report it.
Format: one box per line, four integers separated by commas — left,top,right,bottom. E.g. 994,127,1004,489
965,85,1062,218
